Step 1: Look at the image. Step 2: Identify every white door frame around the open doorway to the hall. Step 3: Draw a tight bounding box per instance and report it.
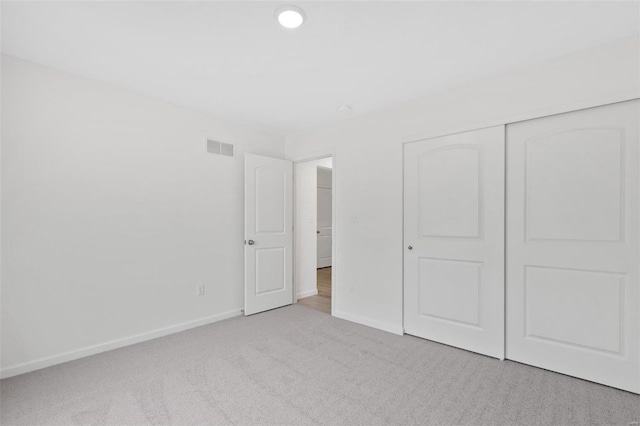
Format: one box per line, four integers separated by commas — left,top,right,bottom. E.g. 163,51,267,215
292,151,339,316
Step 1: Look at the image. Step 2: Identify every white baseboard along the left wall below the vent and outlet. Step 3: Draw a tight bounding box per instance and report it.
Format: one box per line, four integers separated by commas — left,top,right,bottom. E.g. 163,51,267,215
0,308,242,379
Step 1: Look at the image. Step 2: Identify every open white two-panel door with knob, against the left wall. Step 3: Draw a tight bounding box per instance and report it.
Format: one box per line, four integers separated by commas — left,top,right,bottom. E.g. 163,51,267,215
244,154,293,315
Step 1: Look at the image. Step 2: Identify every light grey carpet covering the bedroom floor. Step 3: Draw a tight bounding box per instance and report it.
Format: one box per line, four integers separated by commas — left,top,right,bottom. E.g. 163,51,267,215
0,306,640,425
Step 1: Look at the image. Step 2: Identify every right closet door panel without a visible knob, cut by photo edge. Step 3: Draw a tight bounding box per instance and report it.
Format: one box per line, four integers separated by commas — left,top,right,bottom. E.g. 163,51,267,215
507,101,640,392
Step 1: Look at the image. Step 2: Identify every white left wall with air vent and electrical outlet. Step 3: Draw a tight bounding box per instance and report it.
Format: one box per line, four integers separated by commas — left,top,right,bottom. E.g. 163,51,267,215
1,57,284,376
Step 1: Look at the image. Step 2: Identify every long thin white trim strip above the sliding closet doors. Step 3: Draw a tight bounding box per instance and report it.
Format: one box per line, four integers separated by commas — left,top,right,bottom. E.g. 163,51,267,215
402,90,640,144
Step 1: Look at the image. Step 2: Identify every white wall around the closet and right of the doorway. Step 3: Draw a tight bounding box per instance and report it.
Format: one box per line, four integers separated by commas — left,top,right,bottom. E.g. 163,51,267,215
287,38,640,333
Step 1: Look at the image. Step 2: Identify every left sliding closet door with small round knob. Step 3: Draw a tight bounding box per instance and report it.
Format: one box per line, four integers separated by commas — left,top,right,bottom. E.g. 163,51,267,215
404,126,504,359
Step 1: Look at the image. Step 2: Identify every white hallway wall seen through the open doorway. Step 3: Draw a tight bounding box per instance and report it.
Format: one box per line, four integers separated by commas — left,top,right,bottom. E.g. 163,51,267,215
294,157,333,298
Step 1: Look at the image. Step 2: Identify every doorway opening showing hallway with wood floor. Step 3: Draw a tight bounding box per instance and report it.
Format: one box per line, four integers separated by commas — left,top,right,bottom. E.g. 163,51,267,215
295,157,335,314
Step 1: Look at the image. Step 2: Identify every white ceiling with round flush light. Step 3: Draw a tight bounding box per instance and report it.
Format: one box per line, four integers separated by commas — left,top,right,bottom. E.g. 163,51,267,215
2,0,640,135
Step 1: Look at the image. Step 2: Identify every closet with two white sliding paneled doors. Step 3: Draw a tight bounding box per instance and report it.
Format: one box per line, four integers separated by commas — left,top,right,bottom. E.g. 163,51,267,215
404,100,640,393
